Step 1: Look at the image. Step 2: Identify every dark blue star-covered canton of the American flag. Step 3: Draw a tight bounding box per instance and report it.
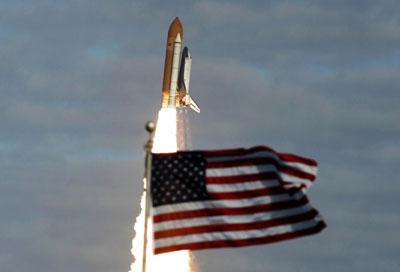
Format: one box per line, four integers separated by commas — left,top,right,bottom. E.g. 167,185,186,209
151,151,208,207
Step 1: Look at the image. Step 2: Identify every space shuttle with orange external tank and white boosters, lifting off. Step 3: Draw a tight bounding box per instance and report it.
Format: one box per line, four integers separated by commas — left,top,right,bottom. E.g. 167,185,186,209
162,17,200,113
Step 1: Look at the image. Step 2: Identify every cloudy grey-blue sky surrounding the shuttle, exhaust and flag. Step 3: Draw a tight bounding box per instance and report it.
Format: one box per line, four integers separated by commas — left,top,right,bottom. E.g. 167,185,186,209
0,0,400,272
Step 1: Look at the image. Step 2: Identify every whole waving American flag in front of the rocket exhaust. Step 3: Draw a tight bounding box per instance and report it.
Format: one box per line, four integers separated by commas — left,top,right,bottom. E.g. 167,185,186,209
151,146,326,254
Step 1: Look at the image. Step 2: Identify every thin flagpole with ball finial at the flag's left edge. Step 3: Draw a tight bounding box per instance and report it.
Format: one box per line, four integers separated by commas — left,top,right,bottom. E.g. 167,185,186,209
142,121,155,272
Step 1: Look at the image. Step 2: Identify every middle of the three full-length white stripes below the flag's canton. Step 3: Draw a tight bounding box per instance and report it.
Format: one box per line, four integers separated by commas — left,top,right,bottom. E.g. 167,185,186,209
153,203,312,231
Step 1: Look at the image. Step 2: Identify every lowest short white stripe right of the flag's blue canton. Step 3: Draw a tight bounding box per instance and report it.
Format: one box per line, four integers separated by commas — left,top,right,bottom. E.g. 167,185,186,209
207,180,280,193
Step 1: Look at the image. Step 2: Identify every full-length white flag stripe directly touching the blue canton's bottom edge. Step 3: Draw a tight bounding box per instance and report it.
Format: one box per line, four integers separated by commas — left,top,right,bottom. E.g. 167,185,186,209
153,192,304,215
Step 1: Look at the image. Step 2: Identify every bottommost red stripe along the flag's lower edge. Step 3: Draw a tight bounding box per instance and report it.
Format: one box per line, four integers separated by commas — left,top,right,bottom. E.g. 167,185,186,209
154,221,326,254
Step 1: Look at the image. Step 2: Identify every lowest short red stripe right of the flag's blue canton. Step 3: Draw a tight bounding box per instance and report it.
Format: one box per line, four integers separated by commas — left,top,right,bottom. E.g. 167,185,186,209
208,186,287,200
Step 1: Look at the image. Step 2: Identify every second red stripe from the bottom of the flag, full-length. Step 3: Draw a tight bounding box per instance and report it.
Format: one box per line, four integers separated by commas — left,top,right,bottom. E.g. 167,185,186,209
154,209,318,239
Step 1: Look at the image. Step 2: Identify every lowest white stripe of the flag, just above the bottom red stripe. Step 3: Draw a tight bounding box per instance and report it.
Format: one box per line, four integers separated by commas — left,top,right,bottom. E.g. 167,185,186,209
154,219,319,248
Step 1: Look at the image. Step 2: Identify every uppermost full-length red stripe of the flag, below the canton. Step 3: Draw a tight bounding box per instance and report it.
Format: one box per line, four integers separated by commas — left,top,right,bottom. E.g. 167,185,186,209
153,196,308,223
